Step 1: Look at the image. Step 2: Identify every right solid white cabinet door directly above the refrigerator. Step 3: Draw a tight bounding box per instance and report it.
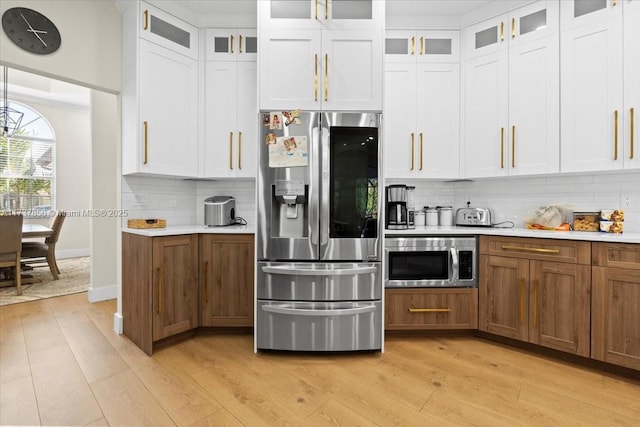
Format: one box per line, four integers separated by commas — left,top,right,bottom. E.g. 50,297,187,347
320,30,383,111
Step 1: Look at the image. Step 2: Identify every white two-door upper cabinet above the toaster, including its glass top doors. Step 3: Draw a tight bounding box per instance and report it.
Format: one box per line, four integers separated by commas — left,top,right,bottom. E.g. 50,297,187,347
463,0,560,178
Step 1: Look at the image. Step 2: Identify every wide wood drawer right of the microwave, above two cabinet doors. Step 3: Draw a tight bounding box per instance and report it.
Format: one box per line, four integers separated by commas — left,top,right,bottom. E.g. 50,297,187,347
480,236,591,264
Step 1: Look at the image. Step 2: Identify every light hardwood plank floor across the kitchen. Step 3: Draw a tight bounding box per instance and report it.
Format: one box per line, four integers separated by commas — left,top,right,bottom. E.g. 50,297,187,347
0,293,640,426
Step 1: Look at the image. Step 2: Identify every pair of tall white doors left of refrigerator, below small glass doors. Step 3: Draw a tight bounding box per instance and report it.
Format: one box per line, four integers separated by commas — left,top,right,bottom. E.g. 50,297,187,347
204,61,258,178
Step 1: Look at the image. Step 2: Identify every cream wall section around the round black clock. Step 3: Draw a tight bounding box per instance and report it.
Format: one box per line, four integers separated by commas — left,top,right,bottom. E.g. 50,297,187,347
0,0,121,93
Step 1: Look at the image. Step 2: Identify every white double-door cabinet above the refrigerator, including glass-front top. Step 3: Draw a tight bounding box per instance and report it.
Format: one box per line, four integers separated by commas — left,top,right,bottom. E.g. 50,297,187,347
258,0,384,111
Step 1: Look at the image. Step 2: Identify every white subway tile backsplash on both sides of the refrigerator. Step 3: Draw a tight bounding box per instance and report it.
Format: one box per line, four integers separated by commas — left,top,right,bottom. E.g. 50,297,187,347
122,171,640,232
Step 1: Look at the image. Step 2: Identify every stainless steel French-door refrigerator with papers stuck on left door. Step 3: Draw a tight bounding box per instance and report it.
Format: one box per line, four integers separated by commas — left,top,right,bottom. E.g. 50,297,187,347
256,112,383,351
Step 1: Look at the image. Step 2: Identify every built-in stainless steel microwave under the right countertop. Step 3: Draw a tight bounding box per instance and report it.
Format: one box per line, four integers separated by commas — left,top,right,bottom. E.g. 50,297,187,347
384,236,478,288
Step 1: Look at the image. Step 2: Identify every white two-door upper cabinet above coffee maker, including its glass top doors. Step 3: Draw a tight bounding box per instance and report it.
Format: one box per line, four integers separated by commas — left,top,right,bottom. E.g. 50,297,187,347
384,30,460,179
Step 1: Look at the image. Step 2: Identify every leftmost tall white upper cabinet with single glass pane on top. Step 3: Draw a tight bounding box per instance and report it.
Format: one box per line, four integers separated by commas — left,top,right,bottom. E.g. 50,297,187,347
121,2,198,177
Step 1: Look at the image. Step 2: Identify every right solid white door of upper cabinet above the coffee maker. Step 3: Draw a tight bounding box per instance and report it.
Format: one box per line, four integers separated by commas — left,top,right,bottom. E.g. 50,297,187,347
416,64,460,179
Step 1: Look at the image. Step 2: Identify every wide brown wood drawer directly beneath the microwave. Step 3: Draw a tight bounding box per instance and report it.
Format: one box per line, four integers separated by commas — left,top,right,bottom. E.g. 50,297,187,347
385,288,478,330
